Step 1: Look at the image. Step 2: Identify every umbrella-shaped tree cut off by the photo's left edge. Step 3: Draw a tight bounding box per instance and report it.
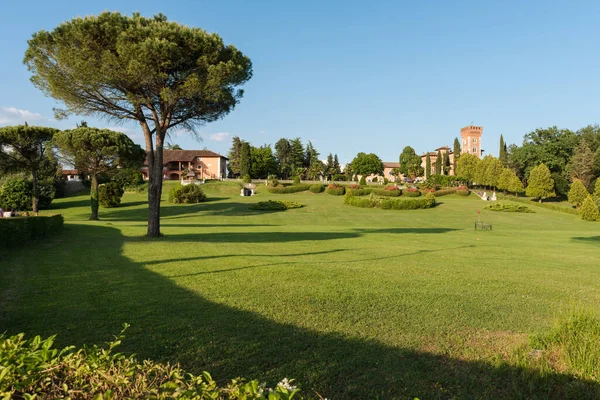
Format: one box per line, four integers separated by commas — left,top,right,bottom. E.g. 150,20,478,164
0,124,58,213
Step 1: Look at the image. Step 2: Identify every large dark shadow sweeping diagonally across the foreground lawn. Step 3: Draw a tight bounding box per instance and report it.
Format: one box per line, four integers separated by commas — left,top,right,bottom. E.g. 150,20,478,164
0,225,600,399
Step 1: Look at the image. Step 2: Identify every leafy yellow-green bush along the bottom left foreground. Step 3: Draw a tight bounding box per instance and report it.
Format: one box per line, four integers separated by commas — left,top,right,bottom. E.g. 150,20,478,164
0,325,299,400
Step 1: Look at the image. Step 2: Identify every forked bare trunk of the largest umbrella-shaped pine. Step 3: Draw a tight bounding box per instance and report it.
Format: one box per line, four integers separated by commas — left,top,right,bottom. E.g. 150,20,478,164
146,134,163,237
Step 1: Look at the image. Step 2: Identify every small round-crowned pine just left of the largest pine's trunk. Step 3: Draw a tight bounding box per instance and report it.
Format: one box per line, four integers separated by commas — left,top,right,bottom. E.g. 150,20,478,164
53,125,145,220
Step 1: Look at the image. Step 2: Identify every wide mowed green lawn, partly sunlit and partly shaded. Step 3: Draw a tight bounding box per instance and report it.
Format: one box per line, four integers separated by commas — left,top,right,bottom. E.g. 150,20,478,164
0,183,600,399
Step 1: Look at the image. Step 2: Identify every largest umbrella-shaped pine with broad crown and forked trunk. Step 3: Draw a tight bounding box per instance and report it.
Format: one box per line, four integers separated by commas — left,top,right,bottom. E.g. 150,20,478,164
24,12,252,237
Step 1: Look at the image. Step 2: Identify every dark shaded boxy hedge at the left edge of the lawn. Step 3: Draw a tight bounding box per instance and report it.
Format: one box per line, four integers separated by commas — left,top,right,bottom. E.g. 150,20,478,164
0,214,64,248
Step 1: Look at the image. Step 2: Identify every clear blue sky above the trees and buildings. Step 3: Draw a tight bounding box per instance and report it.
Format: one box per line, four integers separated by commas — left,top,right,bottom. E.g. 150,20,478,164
0,0,600,162
